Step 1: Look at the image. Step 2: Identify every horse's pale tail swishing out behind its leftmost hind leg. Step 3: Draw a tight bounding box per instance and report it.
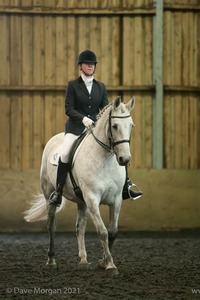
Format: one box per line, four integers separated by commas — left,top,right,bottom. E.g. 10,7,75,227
24,194,65,222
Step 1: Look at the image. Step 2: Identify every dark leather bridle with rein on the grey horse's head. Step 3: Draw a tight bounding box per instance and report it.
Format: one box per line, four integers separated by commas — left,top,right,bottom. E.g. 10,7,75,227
91,111,131,153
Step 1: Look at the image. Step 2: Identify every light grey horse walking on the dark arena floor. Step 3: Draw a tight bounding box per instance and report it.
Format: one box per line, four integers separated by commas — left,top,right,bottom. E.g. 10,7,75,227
24,97,135,274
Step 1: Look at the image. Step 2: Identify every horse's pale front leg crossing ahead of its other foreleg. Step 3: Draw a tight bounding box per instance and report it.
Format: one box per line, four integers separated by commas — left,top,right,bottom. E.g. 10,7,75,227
88,199,117,271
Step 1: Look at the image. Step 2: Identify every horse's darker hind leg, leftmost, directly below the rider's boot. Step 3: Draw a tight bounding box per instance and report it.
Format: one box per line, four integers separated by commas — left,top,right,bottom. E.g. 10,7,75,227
46,204,56,266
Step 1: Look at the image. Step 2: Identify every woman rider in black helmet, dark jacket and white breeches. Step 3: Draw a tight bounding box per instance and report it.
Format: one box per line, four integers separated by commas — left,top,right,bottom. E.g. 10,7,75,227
49,50,142,206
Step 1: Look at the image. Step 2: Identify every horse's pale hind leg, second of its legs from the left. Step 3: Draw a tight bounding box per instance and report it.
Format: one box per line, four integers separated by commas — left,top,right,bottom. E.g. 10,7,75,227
76,203,88,267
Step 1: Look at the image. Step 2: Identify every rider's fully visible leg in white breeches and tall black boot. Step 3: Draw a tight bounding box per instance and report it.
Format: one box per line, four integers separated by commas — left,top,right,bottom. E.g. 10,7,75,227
49,133,78,206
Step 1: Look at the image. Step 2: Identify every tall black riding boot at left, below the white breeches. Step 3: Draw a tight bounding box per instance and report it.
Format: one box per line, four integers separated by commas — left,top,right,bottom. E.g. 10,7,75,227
49,158,69,206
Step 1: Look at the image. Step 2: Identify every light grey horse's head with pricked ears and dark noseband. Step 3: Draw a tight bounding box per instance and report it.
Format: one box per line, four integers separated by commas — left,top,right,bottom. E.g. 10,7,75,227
108,97,135,166
